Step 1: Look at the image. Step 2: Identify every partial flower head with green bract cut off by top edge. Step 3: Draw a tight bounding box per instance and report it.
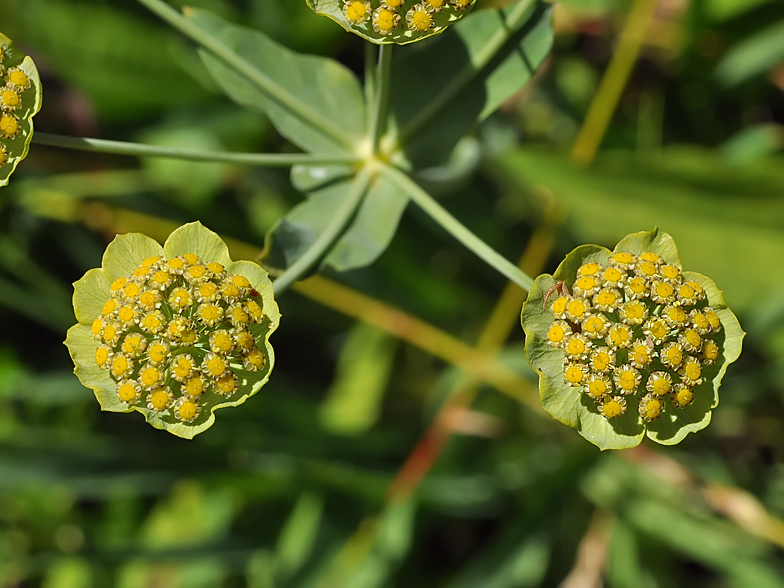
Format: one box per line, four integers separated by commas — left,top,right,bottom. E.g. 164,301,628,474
308,0,476,45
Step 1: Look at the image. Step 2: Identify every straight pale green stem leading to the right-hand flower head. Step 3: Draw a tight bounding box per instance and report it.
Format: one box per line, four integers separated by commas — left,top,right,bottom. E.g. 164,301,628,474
381,164,534,290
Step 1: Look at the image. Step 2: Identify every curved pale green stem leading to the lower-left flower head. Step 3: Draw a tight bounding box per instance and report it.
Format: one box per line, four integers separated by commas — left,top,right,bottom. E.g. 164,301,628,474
273,167,372,294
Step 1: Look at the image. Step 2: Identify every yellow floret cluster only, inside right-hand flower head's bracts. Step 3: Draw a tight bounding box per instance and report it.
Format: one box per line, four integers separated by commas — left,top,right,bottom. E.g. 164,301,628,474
547,252,722,421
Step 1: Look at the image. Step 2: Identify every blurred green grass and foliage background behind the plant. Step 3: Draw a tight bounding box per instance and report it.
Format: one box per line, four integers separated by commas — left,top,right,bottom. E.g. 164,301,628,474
0,0,784,588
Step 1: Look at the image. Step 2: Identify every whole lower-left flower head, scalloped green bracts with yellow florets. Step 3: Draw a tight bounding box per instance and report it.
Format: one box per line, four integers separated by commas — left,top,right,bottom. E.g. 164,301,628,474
65,222,280,439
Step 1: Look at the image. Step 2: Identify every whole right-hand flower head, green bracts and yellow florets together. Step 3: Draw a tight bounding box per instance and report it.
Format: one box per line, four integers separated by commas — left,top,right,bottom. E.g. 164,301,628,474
522,229,745,449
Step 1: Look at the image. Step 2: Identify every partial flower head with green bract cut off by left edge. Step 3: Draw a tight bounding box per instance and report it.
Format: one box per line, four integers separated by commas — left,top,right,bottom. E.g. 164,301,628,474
0,33,41,186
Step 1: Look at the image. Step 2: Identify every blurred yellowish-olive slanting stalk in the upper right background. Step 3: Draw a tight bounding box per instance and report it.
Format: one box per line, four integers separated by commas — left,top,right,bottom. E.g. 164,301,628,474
571,0,658,165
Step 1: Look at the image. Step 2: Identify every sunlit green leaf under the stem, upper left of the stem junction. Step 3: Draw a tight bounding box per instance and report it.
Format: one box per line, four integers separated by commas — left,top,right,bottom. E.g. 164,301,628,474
185,9,366,153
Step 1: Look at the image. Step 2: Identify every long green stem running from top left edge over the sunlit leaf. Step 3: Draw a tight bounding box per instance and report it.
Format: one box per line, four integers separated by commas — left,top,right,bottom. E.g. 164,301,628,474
138,0,355,150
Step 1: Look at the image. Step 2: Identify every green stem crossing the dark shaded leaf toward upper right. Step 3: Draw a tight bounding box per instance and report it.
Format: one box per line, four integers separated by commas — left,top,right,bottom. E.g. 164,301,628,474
400,0,538,142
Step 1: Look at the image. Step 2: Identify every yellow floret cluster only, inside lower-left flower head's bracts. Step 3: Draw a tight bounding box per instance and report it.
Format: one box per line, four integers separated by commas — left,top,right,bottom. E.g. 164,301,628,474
92,254,266,422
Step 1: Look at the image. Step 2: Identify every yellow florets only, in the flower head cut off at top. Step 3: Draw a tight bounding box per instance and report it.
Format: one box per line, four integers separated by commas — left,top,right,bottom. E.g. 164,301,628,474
343,0,471,36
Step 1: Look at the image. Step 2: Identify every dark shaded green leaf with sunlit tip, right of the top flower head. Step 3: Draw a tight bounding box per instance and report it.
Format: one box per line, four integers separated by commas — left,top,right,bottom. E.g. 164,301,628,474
390,0,553,167
